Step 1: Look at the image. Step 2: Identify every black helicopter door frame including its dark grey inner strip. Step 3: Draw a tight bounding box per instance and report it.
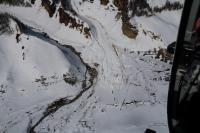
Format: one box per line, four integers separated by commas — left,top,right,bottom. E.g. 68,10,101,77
167,0,200,133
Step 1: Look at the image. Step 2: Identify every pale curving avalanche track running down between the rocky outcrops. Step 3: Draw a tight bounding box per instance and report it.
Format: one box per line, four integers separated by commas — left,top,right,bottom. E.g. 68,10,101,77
71,0,124,89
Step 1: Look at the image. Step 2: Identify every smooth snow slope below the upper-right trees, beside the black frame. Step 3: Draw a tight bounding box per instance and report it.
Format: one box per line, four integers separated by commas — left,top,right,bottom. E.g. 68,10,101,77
136,10,181,46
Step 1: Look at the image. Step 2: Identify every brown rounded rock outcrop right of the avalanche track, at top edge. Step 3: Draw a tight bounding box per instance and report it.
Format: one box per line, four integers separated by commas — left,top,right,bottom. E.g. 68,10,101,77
113,0,138,39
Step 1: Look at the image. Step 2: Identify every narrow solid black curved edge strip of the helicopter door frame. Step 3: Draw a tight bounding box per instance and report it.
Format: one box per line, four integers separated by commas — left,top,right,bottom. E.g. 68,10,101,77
167,0,194,133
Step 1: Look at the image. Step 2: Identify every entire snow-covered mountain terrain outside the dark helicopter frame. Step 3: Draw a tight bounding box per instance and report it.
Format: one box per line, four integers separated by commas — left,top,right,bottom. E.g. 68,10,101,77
0,0,184,133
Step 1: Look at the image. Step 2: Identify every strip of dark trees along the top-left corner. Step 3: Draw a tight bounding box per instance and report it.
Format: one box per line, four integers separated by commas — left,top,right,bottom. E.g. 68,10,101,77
0,0,31,7
